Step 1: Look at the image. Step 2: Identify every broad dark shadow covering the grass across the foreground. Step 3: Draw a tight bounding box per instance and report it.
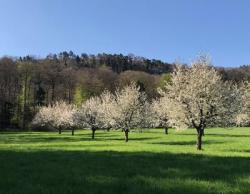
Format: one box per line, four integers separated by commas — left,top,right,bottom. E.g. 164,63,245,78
0,151,250,194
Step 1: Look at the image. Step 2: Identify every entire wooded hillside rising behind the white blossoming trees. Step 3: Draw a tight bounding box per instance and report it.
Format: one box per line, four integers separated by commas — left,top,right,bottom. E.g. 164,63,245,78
0,51,250,130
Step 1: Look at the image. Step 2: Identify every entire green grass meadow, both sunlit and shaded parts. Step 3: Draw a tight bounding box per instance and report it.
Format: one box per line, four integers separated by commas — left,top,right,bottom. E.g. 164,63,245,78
0,128,250,194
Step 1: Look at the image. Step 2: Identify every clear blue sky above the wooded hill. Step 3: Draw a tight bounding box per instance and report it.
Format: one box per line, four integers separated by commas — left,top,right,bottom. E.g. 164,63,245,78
0,0,250,66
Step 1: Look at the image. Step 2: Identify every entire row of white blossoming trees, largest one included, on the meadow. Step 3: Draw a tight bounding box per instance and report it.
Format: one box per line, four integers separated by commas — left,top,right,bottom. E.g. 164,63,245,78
33,56,250,150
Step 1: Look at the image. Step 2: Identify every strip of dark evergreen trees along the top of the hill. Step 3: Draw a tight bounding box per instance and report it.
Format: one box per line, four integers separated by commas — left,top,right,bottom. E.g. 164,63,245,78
36,51,173,74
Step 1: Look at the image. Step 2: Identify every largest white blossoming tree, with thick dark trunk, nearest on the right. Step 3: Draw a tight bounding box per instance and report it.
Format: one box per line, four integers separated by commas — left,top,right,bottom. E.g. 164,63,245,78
163,56,238,150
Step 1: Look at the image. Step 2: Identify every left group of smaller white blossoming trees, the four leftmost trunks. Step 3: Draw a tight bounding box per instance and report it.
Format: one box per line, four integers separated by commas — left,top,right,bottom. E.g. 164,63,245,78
32,83,149,141
